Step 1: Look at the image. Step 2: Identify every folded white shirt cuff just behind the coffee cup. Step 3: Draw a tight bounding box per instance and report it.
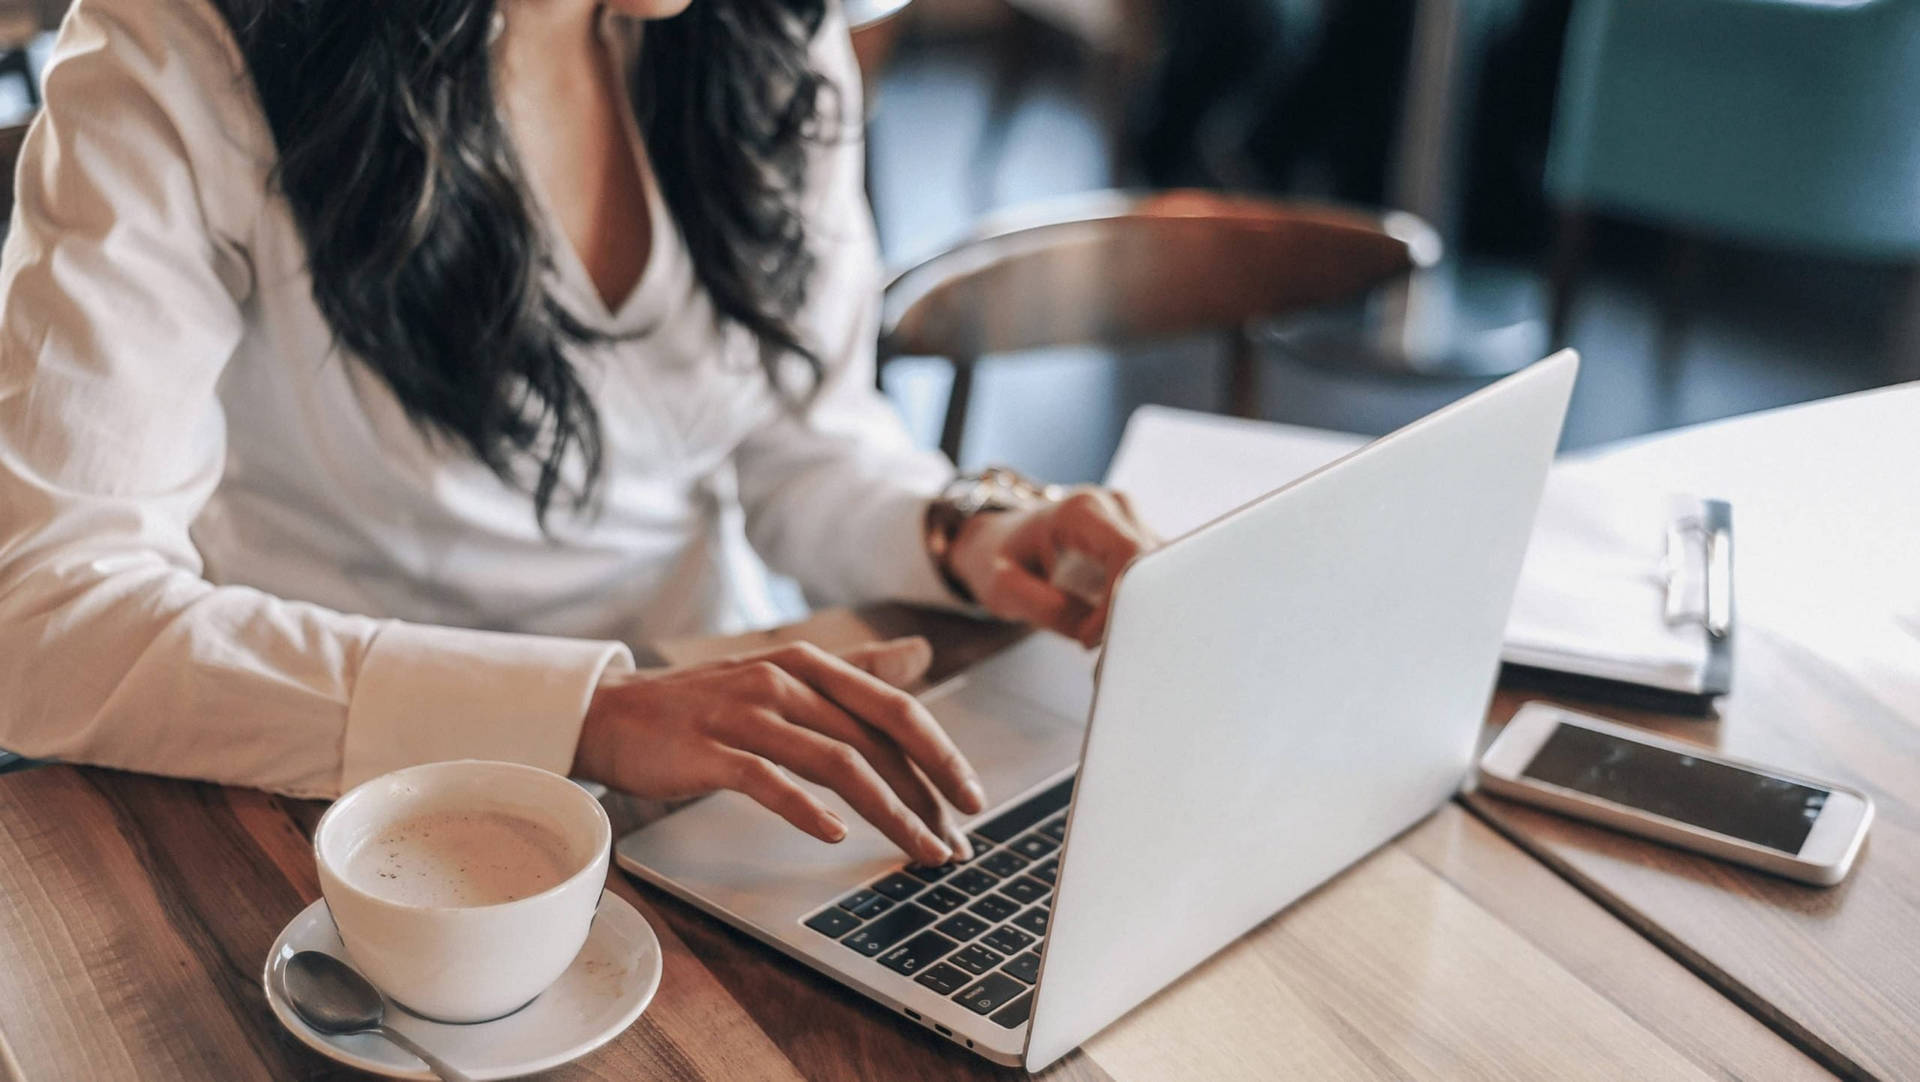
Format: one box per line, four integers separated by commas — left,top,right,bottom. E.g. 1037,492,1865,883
340,620,634,792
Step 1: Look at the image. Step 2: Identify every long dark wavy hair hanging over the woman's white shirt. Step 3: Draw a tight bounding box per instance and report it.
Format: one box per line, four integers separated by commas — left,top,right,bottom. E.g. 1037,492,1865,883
215,0,831,528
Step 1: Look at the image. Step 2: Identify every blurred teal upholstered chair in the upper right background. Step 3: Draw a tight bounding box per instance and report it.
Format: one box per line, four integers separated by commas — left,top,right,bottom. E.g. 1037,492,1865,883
1546,0,1920,358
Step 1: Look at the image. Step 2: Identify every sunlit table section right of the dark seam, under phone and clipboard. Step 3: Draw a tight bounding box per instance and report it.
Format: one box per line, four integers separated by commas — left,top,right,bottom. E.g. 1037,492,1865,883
1471,384,1920,1078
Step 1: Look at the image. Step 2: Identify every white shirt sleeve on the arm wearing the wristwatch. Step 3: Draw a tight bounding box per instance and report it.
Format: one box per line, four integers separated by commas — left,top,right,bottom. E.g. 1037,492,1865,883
733,4,956,606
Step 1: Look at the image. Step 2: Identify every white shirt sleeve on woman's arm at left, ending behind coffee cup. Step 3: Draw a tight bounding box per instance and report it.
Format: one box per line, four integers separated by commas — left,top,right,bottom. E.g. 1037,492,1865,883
0,0,632,796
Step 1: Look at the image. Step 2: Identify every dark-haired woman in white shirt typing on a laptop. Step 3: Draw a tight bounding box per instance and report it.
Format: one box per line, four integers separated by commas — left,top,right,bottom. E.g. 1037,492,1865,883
0,0,1144,861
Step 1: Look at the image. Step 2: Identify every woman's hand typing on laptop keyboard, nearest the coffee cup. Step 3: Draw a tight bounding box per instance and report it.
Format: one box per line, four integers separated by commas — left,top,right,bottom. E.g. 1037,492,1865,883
574,637,985,865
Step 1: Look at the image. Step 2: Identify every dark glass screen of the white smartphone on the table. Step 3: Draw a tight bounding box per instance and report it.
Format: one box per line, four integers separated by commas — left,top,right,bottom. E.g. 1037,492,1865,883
1521,725,1828,854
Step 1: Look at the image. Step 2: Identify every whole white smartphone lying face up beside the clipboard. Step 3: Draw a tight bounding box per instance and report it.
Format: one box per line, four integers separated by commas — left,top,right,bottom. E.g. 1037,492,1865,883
1478,702,1874,886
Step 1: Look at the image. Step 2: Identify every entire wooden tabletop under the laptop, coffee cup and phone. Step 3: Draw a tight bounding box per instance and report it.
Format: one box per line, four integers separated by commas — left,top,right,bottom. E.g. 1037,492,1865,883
0,384,1920,1080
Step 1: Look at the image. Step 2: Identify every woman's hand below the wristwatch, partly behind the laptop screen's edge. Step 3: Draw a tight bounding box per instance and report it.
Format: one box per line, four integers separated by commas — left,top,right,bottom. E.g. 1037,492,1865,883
947,487,1160,647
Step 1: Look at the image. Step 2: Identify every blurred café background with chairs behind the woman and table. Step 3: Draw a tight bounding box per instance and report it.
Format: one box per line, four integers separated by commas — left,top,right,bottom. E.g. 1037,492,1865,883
0,0,1920,482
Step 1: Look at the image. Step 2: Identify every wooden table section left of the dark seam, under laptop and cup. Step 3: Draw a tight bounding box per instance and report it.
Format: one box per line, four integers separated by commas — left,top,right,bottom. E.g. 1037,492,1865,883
0,608,1827,1082
